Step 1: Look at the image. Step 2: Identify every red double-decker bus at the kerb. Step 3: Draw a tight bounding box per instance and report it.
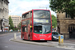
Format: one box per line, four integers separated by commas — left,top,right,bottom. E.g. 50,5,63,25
21,9,52,40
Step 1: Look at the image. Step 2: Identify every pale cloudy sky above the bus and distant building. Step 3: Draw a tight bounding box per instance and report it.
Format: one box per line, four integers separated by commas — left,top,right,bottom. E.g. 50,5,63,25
9,0,56,16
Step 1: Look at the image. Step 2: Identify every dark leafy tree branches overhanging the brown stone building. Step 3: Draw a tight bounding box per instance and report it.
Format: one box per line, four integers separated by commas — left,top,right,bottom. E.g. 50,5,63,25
49,0,75,19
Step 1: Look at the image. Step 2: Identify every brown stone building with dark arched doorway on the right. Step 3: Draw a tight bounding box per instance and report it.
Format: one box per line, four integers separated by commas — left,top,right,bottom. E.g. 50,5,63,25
57,12,75,39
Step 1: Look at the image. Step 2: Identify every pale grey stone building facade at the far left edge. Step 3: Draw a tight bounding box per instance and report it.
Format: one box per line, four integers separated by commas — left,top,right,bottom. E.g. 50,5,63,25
0,0,9,31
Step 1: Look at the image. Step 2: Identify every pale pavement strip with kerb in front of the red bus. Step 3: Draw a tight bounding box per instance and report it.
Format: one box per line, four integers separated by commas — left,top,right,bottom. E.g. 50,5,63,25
9,35,75,50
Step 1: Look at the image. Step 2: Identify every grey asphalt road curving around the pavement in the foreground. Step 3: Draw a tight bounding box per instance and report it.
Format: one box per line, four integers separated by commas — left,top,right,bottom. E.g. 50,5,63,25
0,33,71,50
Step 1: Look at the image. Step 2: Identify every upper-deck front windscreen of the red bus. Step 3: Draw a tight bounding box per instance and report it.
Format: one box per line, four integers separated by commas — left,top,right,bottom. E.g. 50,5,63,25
33,10,50,18
